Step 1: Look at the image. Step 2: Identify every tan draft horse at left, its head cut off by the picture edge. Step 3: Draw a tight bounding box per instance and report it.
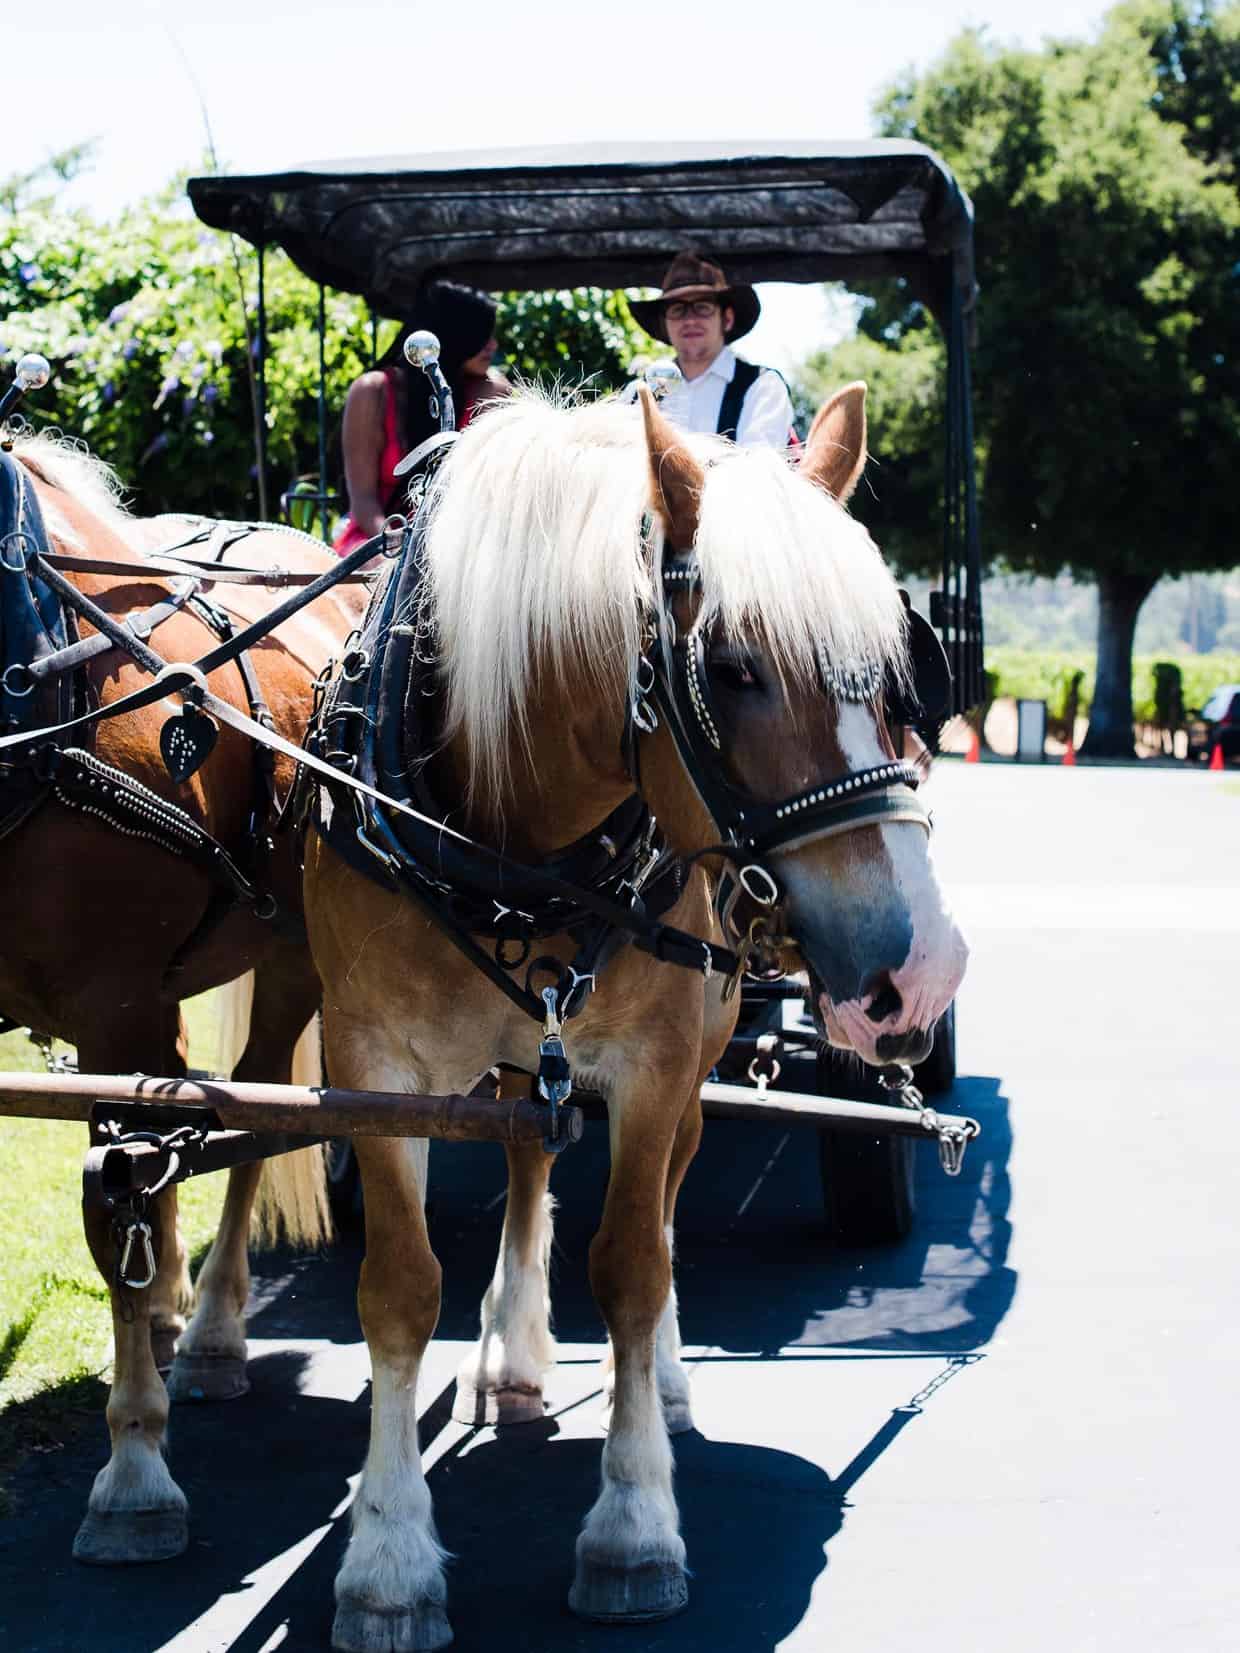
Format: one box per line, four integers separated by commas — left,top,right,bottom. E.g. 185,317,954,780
0,436,362,1562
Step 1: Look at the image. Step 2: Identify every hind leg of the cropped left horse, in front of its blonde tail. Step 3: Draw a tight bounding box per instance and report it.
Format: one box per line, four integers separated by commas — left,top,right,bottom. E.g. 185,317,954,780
169,949,319,1402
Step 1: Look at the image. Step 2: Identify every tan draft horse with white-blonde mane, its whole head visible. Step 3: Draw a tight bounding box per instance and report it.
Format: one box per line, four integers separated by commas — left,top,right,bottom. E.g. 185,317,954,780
306,385,966,1653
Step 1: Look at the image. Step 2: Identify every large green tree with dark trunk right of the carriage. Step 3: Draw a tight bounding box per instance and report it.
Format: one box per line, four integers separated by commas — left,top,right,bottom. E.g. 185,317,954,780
832,0,1240,755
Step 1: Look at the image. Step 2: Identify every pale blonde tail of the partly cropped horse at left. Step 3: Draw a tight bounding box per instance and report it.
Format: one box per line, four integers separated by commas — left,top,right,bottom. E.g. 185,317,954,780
217,970,332,1251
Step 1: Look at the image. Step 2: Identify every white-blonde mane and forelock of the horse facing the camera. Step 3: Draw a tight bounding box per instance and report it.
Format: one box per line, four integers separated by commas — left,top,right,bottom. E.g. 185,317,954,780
427,388,904,798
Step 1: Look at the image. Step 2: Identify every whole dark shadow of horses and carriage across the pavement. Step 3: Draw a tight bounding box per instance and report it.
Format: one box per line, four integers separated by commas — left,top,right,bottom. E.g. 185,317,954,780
0,1079,1015,1653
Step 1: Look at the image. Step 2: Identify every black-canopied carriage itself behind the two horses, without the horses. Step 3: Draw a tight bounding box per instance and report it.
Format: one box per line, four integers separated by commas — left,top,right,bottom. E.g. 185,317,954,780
190,141,982,1243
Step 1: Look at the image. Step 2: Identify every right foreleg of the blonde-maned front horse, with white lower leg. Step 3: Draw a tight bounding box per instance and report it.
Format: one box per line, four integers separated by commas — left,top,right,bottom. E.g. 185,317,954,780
569,1069,689,1623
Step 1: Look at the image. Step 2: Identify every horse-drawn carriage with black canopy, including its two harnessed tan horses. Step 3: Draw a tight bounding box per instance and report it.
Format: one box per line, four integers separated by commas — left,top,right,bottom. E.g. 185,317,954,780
0,144,980,1648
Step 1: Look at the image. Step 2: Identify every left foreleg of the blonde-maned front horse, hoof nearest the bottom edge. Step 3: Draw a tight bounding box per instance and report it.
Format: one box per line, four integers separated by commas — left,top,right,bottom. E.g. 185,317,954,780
329,1110,451,1653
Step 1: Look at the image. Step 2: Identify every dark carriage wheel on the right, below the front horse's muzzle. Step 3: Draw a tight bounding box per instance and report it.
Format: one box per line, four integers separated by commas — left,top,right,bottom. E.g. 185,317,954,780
818,1051,916,1246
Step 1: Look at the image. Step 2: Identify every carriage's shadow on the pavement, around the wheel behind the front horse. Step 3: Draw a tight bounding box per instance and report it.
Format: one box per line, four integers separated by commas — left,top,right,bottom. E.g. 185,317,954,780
419,1078,1015,1357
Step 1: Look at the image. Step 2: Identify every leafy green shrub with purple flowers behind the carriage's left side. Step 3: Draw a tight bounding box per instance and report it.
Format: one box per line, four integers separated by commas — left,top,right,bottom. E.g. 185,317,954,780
0,181,648,517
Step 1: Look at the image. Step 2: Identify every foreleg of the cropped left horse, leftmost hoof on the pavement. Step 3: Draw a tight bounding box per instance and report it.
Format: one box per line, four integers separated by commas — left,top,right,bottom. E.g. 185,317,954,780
73,1005,188,1564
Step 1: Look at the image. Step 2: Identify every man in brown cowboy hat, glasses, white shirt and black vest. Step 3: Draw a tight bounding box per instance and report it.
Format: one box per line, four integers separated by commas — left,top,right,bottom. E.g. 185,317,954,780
628,248,795,448
